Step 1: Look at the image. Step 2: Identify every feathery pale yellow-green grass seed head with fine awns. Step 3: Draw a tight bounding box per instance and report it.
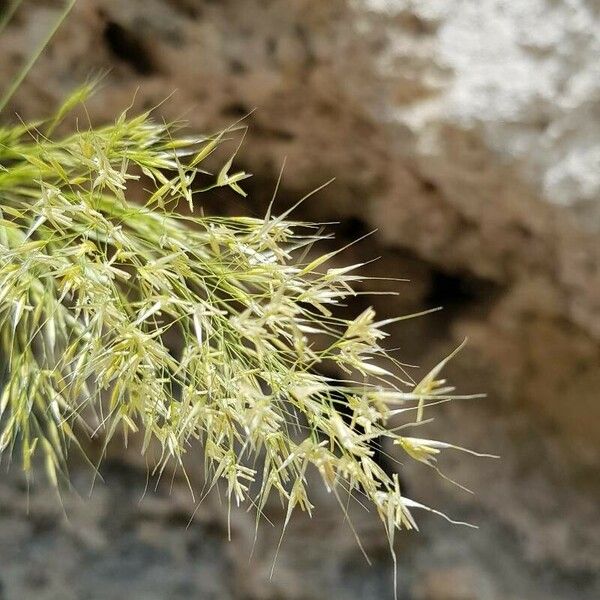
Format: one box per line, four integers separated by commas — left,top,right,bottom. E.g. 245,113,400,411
0,88,488,564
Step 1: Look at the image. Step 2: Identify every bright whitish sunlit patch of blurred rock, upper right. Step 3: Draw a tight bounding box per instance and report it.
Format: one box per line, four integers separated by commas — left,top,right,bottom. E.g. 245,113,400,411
366,0,600,213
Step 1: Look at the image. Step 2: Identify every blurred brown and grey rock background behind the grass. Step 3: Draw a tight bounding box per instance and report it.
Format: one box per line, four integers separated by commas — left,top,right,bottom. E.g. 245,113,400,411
0,0,600,600
